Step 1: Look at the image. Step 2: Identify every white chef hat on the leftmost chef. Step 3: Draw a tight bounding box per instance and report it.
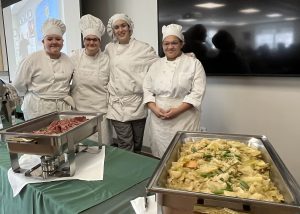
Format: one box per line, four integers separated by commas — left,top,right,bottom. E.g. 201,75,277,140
42,19,66,37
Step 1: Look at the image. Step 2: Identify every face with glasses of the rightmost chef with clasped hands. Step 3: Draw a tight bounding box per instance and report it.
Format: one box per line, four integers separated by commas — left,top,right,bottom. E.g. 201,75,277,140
162,35,183,61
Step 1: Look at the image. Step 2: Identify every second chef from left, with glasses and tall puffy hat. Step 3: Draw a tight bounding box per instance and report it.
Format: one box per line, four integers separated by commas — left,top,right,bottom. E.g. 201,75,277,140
71,14,112,145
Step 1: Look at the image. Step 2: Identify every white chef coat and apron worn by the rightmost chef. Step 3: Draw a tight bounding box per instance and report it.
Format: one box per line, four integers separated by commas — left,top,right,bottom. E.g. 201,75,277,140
143,54,206,158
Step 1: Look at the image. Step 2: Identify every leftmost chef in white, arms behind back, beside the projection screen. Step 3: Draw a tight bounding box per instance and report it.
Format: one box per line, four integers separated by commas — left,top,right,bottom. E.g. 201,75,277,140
13,19,74,120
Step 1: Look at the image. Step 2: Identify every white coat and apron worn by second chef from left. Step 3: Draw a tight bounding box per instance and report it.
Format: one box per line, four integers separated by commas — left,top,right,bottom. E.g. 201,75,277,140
71,49,112,144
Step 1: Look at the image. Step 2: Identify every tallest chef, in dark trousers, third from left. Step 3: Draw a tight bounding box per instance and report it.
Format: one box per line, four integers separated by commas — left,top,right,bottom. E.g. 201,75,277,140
105,14,158,152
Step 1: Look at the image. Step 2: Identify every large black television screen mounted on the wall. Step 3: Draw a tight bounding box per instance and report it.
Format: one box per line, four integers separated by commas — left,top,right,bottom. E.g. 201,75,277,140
158,0,300,76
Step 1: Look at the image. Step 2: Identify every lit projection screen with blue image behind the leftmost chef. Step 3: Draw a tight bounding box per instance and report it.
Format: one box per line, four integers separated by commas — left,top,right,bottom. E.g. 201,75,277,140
3,0,81,80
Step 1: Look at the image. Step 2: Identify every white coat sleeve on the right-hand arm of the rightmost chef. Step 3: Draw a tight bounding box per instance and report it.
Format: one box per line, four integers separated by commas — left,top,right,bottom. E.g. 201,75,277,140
183,60,206,110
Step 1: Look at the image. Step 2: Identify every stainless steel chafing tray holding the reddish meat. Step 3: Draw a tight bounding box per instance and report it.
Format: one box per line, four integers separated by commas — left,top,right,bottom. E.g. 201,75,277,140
0,111,103,156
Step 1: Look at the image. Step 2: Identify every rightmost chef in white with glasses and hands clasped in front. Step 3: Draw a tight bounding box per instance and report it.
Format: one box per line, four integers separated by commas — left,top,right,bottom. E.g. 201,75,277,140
143,24,206,158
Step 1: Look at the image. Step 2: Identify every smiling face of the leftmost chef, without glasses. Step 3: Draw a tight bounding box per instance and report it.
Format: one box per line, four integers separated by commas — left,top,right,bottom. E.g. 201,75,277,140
42,35,64,59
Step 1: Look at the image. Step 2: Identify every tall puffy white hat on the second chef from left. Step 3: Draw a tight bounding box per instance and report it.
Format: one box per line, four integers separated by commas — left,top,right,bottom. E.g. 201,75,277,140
80,14,105,39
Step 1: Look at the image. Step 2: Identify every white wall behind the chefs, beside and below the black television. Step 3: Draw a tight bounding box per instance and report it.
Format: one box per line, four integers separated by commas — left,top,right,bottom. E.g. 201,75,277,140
85,0,300,183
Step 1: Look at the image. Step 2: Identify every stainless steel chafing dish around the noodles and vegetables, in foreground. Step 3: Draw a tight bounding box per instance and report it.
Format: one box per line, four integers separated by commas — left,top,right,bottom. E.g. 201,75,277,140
147,132,300,214
